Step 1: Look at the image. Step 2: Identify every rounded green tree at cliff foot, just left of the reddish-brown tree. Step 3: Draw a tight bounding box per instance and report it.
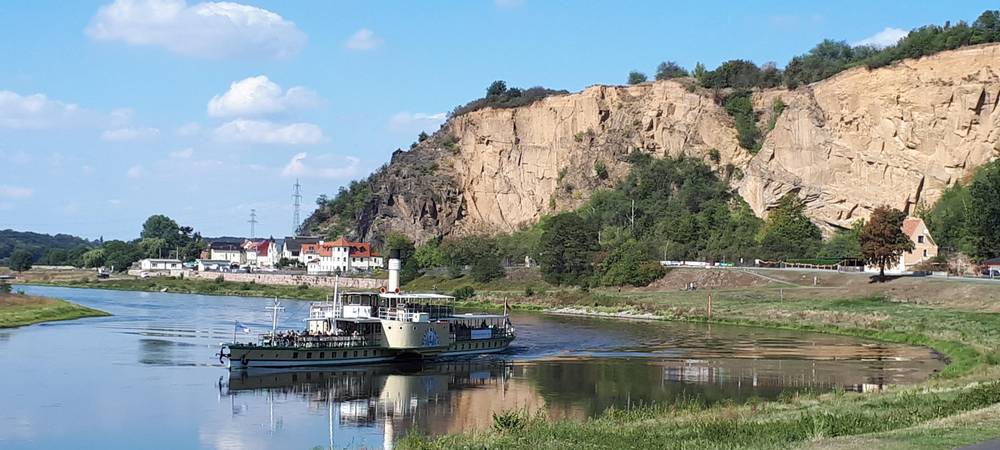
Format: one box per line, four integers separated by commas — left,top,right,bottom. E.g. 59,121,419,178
760,192,823,260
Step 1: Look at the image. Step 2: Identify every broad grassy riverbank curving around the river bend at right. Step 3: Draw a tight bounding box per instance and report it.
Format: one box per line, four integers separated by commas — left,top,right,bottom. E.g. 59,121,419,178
400,274,1000,449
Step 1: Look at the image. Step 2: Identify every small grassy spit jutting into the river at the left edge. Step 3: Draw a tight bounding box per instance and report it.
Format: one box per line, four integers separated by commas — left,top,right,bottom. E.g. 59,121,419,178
0,294,109,328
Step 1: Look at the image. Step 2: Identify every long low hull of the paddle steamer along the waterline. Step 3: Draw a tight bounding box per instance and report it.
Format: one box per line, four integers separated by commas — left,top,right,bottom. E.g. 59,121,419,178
228,337,513,370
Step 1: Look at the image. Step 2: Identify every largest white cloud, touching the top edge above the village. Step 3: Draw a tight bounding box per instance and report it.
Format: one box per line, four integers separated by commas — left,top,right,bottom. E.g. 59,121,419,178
85,0,306,58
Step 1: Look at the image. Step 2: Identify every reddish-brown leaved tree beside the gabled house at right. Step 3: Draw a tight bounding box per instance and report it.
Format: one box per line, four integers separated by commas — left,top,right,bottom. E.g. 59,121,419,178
860,206,913,281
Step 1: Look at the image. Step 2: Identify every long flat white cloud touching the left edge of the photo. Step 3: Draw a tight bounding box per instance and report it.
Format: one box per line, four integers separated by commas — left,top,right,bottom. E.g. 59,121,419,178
0,91,86,130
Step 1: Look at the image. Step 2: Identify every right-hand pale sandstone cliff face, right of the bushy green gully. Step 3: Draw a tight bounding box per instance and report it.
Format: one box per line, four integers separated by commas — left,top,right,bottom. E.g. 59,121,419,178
739,45,1000,229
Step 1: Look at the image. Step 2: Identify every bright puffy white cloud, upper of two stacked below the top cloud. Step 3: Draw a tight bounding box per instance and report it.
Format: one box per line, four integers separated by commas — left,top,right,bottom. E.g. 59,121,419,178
208,75,321,117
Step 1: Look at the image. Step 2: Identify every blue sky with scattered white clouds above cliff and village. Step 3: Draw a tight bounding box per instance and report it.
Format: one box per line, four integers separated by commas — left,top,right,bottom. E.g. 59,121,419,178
0,0,996,238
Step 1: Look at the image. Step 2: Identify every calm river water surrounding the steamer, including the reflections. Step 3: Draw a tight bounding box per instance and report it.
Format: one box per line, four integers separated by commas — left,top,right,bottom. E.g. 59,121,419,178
0,286,944,449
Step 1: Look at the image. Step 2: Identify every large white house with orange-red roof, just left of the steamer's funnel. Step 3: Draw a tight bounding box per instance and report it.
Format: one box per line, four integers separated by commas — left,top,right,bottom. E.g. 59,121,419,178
300,236,382,274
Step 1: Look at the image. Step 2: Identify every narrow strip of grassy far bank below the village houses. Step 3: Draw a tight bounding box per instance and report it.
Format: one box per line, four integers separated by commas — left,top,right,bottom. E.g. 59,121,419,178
22,277,333,300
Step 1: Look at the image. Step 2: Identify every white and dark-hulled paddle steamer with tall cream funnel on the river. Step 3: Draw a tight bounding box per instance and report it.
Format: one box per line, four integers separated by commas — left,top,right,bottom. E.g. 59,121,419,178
219,251,515,370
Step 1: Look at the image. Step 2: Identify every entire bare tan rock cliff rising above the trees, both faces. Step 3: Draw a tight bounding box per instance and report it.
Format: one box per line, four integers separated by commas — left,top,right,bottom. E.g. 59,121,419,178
309,45,1000,241
